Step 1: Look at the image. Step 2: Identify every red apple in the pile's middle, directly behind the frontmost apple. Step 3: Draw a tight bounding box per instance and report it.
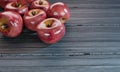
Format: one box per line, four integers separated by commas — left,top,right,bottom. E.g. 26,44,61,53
23,9,46,31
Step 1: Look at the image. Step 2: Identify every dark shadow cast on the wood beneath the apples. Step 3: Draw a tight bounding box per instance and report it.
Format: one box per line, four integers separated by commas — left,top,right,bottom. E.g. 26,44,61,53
0,30,50,53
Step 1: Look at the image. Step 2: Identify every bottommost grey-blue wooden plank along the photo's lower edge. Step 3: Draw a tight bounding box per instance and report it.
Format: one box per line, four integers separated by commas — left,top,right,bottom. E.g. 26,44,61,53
0,66,120,72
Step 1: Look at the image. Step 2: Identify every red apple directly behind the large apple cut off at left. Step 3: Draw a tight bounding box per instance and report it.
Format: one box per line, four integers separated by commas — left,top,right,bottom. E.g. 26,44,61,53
5,2,28,15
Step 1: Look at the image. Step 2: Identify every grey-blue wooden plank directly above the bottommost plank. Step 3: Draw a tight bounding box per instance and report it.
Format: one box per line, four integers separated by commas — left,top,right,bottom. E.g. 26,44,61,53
0,58,120,67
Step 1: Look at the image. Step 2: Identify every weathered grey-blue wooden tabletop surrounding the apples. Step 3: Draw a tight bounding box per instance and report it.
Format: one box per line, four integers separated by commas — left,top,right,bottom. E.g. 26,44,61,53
0,0,120,72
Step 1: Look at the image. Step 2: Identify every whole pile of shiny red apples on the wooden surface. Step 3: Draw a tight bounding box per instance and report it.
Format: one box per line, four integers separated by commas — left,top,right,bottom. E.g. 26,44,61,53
0,0,70,44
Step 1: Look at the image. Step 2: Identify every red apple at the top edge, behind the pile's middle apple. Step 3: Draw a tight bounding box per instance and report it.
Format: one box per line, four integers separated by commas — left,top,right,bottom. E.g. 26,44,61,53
30,0,50,11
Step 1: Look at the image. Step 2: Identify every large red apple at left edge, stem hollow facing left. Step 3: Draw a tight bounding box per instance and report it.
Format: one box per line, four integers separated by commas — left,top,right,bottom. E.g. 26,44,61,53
0,11,23,37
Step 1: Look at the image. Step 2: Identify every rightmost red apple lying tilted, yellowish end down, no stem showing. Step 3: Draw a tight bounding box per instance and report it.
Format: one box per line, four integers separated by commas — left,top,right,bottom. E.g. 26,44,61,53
47,2,70,23
